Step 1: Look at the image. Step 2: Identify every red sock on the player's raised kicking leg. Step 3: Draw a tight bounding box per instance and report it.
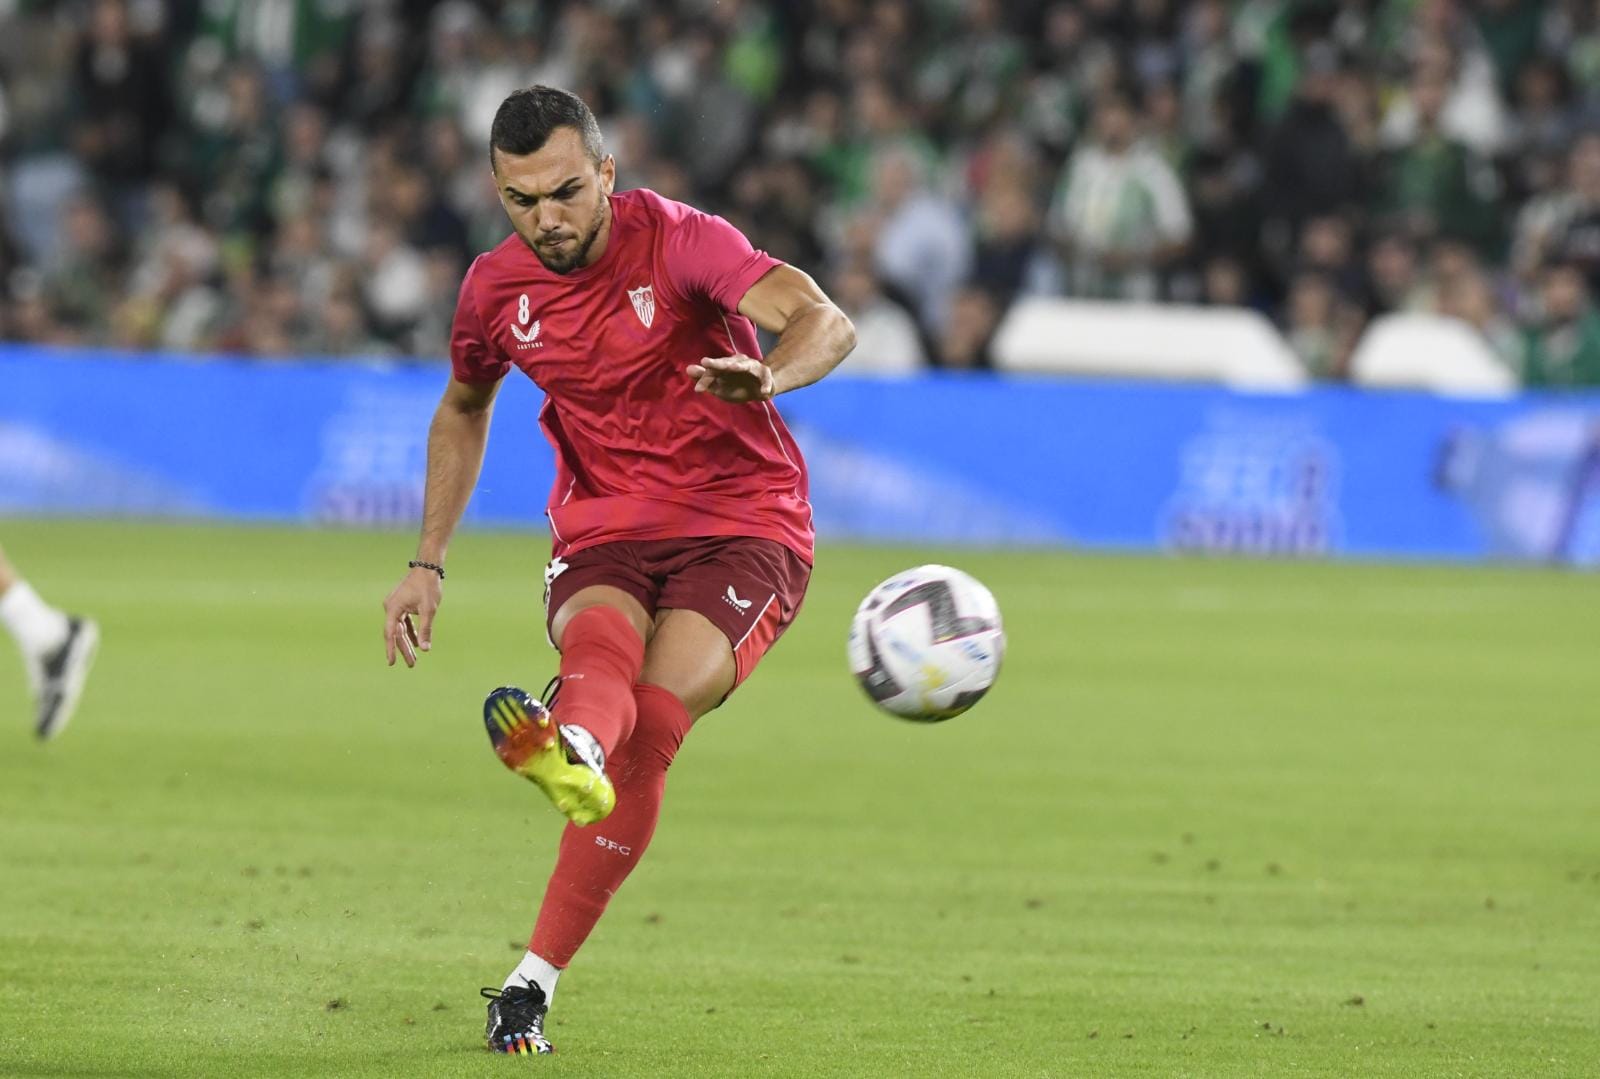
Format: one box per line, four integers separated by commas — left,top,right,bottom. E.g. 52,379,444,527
555,605,645,760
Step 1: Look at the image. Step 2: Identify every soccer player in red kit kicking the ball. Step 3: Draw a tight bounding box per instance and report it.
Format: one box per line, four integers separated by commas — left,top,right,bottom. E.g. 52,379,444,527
384,86,854,1053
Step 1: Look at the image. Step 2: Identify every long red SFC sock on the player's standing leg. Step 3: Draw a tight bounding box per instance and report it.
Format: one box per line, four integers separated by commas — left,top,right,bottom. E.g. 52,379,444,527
528,685,693,967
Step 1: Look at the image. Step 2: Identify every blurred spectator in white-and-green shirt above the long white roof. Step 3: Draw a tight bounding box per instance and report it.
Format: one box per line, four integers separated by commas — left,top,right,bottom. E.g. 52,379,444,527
1051,91,1192,299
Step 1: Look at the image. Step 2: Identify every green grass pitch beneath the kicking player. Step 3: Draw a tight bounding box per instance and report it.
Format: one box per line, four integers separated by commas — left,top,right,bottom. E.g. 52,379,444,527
0,520,1600,1077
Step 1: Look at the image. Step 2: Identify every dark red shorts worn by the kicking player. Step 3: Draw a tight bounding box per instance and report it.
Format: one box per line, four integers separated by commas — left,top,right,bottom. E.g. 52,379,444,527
544,536,811,685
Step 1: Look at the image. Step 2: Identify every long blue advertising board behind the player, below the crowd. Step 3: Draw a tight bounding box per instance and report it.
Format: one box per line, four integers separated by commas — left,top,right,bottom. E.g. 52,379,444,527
0,347,1600,565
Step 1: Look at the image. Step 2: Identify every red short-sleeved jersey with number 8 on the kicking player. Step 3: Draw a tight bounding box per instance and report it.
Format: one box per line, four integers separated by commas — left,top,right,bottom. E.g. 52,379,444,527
450,191,813,562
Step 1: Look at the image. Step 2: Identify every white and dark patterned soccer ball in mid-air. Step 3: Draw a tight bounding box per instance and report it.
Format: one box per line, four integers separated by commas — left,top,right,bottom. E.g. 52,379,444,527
850,565,1005,724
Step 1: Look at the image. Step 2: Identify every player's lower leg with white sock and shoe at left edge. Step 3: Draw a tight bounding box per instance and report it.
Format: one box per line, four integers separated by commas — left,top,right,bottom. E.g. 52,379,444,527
0,549,99,741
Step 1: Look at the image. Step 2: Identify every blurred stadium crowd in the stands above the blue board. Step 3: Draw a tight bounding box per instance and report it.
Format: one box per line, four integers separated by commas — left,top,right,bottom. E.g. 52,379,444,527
9,0,1600,386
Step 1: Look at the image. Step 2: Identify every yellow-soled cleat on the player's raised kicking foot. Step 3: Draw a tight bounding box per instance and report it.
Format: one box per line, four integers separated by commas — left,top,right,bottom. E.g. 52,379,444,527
483,685,616,824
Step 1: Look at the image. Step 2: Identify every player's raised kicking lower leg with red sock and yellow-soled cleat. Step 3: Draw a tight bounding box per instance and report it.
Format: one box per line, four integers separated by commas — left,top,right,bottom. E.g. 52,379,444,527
483,584,650,824
